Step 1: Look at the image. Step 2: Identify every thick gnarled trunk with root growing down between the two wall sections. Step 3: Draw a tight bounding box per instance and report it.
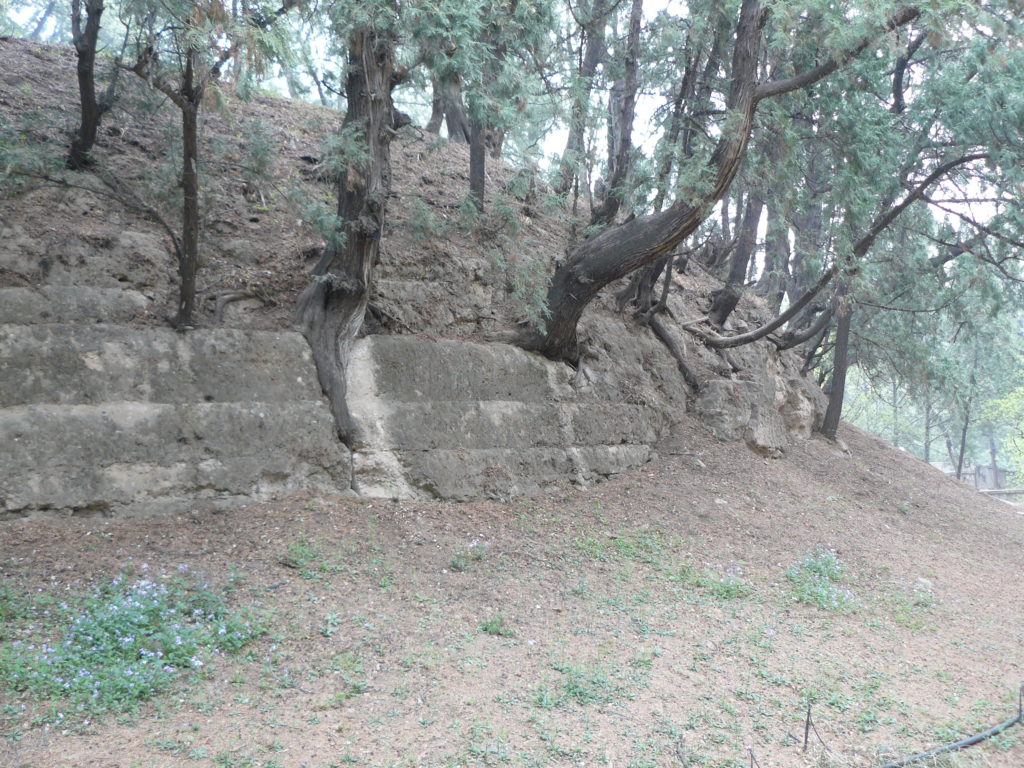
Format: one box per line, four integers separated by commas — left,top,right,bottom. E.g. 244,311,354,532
297,29,394,445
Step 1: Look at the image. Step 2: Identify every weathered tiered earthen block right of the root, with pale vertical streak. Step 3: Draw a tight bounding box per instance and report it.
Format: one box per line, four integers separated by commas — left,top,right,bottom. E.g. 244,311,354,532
348,336,669,500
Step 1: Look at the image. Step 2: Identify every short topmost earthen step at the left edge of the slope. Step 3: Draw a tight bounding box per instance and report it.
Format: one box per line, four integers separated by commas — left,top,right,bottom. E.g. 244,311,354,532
0,286,150,326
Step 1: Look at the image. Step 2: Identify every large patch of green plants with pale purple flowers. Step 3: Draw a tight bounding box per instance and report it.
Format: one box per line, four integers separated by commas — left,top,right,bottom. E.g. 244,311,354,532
0,573,264,722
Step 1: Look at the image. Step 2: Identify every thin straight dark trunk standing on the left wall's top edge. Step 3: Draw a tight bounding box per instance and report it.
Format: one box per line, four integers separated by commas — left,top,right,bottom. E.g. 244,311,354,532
174,49,203,330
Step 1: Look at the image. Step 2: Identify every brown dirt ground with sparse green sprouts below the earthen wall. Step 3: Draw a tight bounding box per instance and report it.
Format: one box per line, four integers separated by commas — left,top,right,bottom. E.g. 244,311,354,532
0,425,1024,768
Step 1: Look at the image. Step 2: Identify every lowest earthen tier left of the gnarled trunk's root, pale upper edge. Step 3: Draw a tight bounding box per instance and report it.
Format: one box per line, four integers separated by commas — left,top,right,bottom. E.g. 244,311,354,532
0,400,351,517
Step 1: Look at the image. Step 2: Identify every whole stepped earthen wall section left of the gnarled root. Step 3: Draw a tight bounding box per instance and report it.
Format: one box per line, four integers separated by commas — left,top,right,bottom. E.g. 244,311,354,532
0,287,351,517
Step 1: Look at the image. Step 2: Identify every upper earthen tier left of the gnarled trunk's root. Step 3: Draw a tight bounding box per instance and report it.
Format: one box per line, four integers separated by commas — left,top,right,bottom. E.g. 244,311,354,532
0,324,321,407
